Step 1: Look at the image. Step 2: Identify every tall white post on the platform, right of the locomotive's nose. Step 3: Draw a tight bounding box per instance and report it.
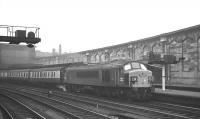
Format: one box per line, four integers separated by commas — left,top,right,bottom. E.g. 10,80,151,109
160,37,167,91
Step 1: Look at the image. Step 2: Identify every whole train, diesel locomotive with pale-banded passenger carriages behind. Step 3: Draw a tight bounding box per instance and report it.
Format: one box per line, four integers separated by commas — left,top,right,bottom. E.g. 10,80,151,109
0,60,153,99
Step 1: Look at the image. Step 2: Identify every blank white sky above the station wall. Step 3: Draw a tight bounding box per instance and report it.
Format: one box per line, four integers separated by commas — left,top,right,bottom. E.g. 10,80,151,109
0,0,200,53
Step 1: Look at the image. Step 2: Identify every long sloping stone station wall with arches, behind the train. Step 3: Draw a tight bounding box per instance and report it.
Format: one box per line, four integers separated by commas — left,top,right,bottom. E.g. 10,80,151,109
35,25,200,87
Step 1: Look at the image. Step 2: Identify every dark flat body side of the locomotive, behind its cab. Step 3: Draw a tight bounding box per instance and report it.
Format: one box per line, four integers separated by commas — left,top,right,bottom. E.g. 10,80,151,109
64,69,115,86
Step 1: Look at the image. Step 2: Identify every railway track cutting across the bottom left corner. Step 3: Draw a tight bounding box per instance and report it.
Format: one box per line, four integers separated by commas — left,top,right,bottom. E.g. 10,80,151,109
0,94,46,119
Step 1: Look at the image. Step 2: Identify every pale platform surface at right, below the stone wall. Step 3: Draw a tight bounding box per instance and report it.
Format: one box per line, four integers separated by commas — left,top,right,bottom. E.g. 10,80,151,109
155,88,200,98
